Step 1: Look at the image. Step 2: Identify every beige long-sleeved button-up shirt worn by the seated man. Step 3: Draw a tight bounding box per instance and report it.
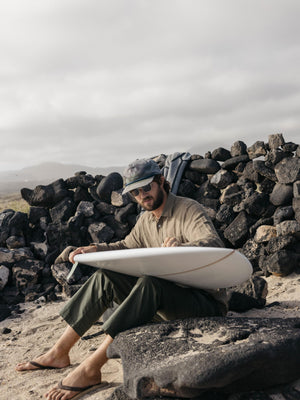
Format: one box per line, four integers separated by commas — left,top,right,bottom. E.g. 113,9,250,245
95,193,227,309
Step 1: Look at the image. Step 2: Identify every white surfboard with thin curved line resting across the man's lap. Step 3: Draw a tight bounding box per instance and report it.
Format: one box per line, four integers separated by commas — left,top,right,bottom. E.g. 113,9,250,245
74,247,252,289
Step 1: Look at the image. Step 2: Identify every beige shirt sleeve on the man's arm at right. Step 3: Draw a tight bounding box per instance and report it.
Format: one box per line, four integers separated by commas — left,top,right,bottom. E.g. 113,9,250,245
181,202,225,247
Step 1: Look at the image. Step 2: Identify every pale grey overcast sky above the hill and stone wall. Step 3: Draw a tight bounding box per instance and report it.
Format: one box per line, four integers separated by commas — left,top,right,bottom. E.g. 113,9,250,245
0,0,300,171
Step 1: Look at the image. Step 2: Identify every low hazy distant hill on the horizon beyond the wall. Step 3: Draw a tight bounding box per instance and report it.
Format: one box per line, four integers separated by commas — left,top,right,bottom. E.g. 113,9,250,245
0,162,124,195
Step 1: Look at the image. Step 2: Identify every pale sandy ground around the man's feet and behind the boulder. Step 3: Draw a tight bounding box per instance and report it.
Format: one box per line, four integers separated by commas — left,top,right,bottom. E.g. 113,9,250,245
0,273,300,400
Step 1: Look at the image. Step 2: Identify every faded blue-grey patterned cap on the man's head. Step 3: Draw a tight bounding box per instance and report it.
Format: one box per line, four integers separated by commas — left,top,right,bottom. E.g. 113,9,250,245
123,159,161,194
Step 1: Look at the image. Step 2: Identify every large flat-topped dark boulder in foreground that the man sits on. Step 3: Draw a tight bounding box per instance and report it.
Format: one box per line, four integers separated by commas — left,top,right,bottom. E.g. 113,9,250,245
108,318,300,399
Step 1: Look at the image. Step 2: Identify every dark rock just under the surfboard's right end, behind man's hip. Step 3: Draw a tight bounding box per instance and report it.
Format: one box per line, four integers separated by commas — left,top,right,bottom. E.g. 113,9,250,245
228,276,268,312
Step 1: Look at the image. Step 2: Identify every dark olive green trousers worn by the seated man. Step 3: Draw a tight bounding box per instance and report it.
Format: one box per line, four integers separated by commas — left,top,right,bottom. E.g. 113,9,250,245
60,269,222,338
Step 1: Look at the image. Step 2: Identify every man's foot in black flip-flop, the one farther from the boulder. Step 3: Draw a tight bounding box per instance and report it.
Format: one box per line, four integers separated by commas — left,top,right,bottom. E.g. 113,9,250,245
16,349,70,372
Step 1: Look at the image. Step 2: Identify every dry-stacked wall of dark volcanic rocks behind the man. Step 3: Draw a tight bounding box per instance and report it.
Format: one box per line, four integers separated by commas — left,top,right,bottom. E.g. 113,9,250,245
0,134,300,316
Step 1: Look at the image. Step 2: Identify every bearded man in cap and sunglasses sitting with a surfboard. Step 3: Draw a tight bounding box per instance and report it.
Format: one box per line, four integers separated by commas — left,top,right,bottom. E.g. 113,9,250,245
16,160,227,400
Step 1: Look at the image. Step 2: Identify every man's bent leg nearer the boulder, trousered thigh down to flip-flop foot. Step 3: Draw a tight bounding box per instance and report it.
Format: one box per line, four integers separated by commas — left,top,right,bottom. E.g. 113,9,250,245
42,271,220,400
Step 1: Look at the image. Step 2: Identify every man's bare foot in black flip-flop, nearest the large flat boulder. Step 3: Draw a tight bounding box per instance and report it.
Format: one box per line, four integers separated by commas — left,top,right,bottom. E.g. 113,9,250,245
45,363,101,400
